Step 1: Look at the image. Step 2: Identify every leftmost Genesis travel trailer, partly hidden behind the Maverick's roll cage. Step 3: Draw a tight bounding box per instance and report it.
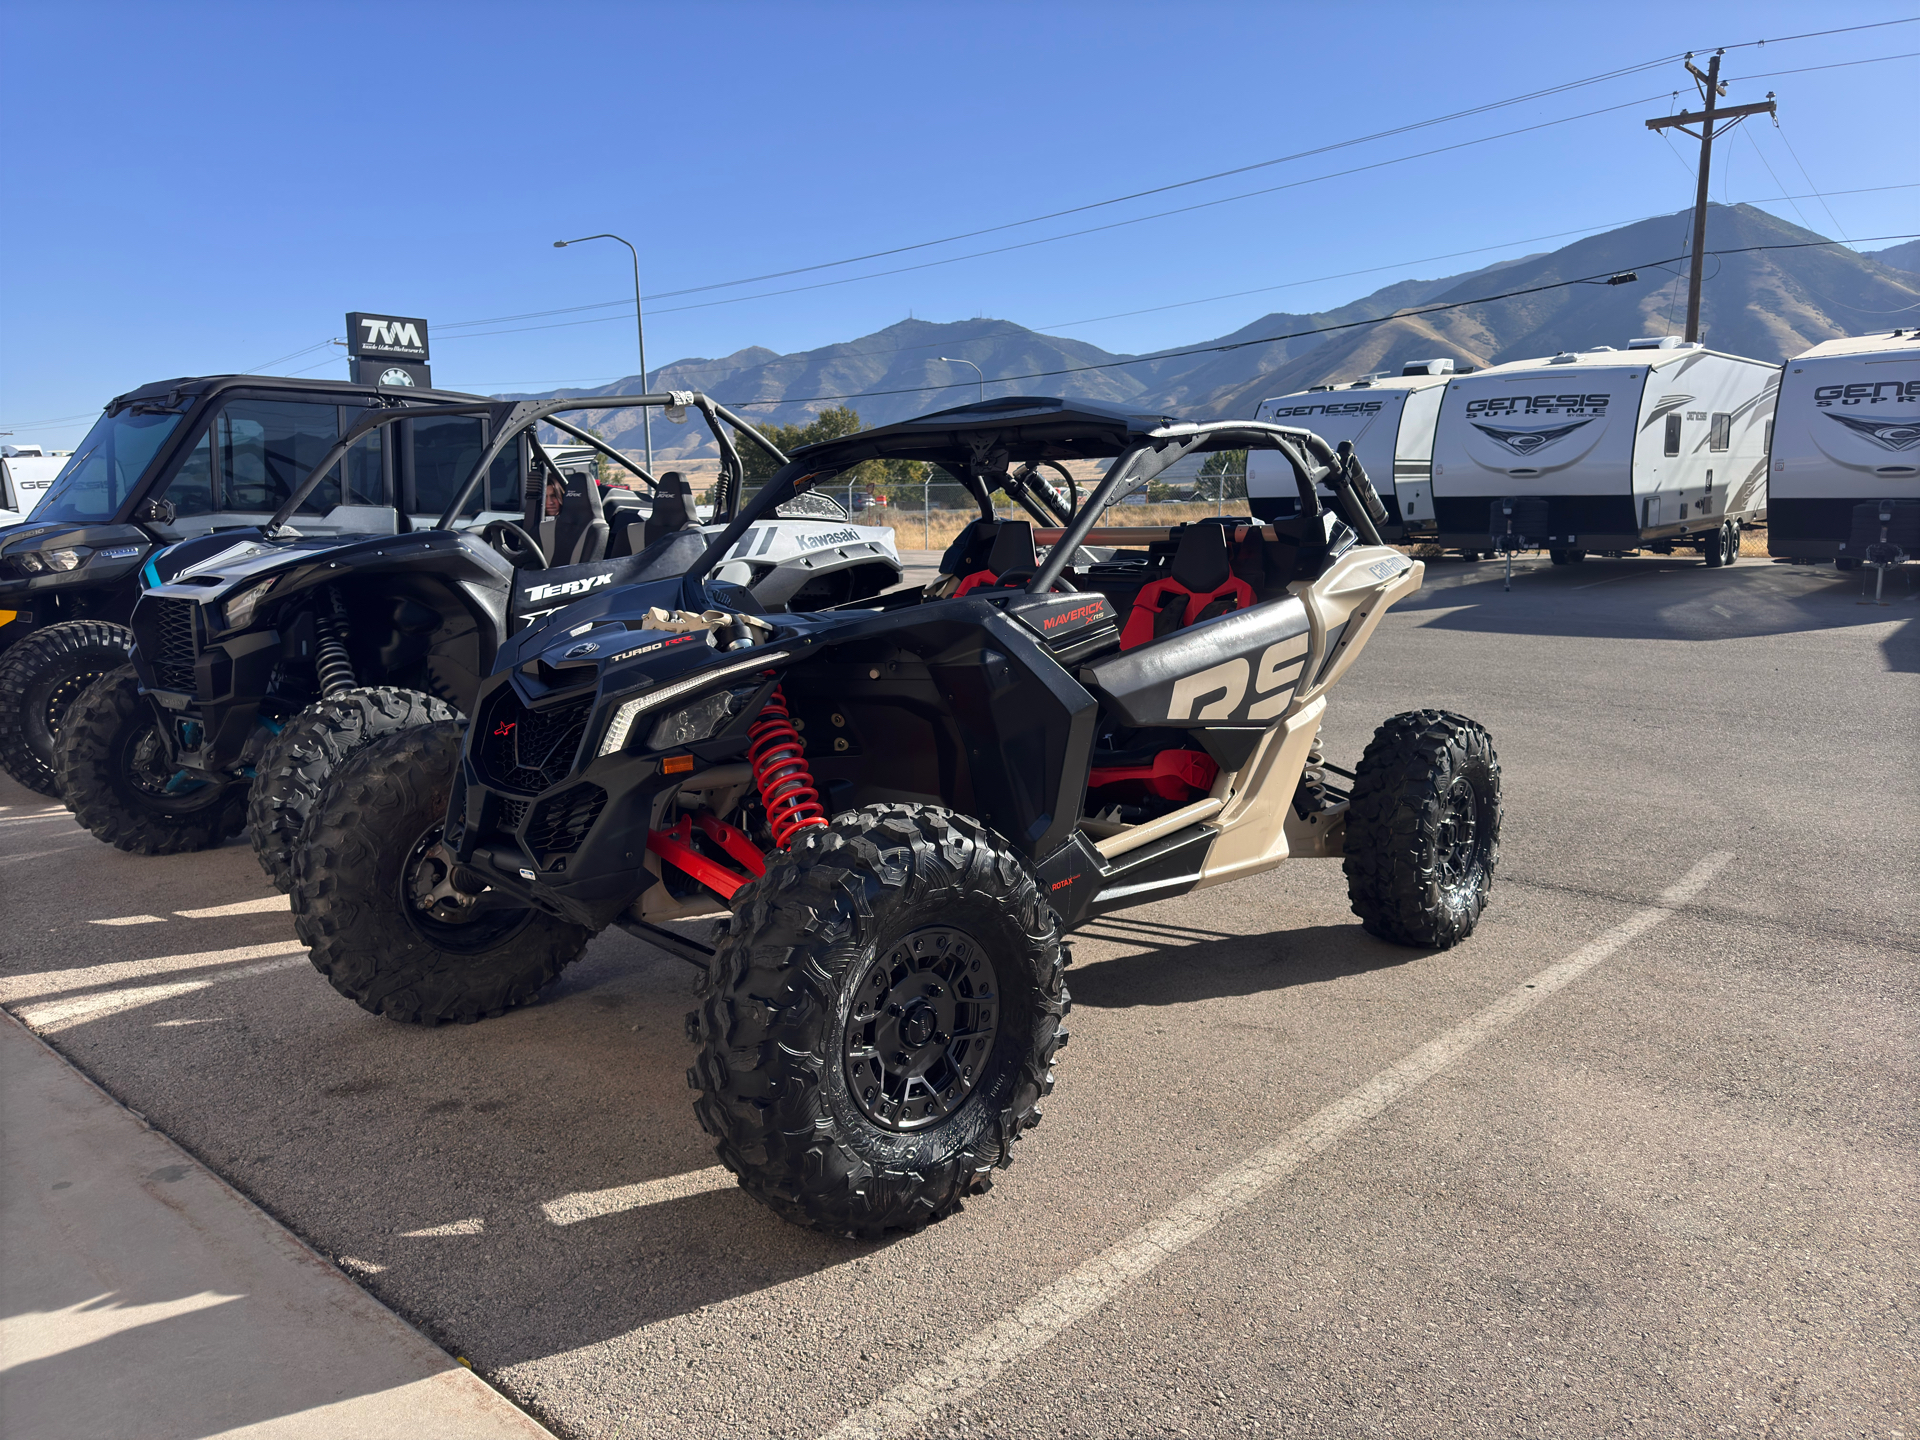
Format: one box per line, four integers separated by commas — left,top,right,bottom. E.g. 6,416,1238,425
1246,359,1473,540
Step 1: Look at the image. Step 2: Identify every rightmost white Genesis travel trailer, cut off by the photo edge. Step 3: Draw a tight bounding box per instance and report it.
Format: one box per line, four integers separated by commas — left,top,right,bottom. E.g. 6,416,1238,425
1766,328,1920,570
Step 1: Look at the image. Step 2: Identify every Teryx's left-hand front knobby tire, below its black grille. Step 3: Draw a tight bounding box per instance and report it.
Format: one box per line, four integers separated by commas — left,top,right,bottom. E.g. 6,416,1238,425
60,664,246,854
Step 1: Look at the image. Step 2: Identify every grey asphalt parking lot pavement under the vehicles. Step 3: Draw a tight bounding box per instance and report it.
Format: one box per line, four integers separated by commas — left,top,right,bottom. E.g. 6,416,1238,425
0,557,1920,1438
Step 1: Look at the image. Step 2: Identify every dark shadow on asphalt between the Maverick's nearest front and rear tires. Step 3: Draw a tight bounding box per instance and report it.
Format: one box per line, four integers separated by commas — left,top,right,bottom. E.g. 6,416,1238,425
1068,920,1428,1010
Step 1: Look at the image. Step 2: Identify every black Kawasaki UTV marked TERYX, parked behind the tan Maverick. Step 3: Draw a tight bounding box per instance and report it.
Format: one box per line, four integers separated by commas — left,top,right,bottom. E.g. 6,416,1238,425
61,394,899,889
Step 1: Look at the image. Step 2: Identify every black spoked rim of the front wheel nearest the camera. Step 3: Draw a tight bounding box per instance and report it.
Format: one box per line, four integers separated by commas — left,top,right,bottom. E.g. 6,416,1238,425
841,925,1000,1133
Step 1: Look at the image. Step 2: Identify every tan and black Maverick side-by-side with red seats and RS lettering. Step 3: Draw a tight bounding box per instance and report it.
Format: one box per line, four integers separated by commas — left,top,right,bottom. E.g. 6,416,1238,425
292,397,1500,1235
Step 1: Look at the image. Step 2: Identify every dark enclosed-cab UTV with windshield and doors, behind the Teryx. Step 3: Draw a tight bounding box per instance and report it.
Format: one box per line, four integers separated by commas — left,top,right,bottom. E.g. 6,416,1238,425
0,374,503,795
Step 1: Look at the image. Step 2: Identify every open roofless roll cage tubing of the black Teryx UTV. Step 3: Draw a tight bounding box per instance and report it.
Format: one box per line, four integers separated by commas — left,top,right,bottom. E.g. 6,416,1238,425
265,390,787,538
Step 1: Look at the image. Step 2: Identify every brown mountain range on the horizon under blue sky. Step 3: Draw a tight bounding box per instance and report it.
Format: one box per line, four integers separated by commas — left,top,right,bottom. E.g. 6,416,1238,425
513,205,1920,463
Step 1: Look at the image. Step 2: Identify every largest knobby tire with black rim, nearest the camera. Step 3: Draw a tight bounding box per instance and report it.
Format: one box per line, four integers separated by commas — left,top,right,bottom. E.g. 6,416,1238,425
687,804,1069,1238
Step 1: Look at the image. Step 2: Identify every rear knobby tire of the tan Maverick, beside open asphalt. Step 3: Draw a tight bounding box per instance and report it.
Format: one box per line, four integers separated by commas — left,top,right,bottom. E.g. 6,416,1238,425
1346,710,1501,950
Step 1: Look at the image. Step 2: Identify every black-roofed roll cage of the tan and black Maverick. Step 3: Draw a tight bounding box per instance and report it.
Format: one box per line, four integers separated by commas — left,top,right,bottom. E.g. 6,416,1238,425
687,396,1386,595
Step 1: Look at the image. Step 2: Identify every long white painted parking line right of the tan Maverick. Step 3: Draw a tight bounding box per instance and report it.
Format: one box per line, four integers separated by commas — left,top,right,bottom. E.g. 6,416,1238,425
826,851,1734,1440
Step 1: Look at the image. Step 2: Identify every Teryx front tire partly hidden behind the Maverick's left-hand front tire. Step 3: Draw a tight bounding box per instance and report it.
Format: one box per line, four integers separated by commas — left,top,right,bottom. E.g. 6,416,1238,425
246,685,461,891
